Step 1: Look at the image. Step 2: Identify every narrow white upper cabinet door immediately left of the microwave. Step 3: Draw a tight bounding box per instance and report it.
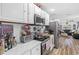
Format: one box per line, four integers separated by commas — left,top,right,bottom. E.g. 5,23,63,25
27,3,34,24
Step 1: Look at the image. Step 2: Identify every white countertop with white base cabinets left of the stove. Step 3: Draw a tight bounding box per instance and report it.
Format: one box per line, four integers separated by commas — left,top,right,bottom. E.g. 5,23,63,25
3,40,41,55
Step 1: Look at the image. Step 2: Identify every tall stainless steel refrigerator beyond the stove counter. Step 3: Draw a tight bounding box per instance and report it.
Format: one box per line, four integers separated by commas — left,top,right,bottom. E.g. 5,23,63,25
49,21,60,48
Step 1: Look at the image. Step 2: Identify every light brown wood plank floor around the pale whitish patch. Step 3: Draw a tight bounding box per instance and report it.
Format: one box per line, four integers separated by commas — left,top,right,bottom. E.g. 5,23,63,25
49,37,79,55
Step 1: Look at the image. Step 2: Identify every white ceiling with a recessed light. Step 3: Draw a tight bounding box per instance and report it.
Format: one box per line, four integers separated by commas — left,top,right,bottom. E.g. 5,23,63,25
41,3,79,19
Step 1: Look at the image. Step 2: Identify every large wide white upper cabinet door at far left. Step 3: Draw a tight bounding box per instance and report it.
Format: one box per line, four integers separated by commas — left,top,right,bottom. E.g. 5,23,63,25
2,3,24,22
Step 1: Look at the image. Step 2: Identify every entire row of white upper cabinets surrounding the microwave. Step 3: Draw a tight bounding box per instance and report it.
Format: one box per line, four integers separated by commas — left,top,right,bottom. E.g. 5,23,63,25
0,3,49,25
